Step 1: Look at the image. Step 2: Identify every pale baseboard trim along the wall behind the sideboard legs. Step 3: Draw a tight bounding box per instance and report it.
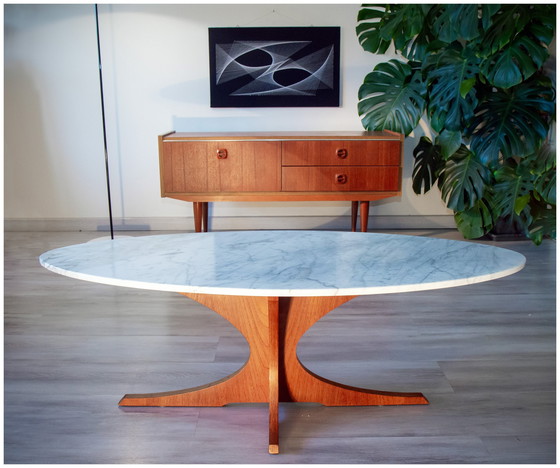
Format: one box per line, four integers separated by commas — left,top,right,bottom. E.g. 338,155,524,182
4,215,455,232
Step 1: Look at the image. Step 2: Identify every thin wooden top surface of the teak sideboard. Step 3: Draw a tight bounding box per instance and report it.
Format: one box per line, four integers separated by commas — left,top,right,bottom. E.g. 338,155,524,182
161,131,404,141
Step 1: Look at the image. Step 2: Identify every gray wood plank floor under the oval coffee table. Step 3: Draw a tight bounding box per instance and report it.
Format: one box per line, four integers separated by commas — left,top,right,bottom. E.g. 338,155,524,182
4,231,556,464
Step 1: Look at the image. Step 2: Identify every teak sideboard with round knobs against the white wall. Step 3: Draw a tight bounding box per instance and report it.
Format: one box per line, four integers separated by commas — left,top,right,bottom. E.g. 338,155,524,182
159,132,404,232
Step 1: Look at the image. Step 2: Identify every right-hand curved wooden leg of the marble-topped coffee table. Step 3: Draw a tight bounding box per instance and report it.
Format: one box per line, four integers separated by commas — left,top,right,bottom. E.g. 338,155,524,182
280,297,428,406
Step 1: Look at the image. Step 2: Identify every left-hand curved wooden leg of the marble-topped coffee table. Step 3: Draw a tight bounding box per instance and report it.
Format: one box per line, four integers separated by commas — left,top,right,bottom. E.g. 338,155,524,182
119,294,269,406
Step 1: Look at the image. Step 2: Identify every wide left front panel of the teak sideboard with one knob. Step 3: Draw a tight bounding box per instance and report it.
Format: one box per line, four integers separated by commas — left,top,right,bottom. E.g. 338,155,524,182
162,141,282,193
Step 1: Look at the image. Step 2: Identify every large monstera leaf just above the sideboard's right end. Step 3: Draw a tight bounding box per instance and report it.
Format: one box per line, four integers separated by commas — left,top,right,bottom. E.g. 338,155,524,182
358,60,426,135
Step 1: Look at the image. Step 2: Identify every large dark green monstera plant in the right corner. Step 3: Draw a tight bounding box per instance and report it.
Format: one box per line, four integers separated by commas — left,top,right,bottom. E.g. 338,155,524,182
356,4,556,244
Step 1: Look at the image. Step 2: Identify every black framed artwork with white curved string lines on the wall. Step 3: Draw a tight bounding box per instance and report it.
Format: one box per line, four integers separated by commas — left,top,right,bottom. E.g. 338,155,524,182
208,27,340,107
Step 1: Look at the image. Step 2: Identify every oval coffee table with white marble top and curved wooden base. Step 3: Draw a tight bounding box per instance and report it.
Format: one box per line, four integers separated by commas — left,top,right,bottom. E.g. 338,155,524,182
39,231,525,454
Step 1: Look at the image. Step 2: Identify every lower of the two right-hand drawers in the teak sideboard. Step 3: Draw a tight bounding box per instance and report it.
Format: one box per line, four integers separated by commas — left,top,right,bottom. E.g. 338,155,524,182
282,166,400,192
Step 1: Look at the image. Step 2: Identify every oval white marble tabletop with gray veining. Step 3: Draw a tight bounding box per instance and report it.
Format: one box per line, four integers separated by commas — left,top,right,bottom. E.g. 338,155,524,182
39,231,525,297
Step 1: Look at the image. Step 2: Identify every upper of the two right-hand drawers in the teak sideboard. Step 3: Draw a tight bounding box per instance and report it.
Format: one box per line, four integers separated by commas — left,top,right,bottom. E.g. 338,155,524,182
282,140,401,166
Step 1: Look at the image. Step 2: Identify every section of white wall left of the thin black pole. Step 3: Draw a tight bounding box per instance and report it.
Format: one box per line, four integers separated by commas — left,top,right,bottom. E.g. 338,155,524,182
4,5,107,218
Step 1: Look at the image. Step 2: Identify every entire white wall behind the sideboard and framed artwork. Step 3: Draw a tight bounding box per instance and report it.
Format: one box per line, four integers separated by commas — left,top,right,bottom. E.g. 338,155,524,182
5,4,452,228
